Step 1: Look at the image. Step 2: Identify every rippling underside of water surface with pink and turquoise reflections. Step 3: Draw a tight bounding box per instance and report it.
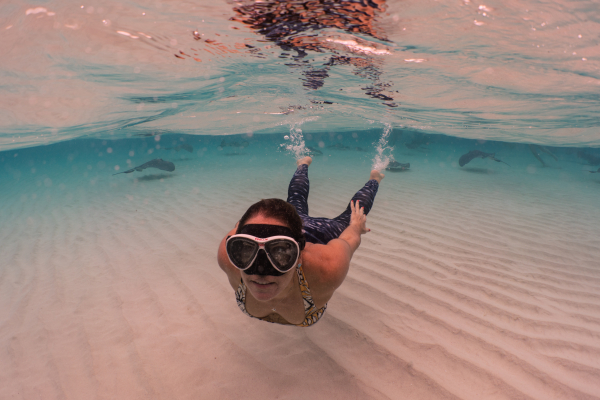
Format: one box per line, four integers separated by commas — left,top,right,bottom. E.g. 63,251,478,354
0,0,600,150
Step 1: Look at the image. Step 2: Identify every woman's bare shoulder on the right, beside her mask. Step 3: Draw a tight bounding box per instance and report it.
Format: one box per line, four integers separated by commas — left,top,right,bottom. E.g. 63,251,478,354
302,239,352,296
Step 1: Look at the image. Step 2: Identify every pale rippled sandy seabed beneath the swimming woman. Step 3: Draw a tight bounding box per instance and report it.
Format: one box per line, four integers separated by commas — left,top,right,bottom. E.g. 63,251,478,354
0,145,600,400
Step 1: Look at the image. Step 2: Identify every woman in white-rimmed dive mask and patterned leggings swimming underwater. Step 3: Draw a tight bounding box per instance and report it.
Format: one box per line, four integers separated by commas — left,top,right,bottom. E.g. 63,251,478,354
218,157,384,326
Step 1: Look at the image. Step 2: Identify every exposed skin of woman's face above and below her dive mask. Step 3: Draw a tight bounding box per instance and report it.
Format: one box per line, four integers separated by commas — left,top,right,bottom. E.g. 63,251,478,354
241,215,300,301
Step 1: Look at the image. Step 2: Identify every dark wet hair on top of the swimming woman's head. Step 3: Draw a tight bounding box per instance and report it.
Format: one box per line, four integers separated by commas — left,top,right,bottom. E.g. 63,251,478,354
236,199,304,245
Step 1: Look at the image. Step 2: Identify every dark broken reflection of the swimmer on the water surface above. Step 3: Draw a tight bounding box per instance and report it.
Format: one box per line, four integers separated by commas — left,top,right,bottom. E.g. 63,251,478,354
231,0,397,107
